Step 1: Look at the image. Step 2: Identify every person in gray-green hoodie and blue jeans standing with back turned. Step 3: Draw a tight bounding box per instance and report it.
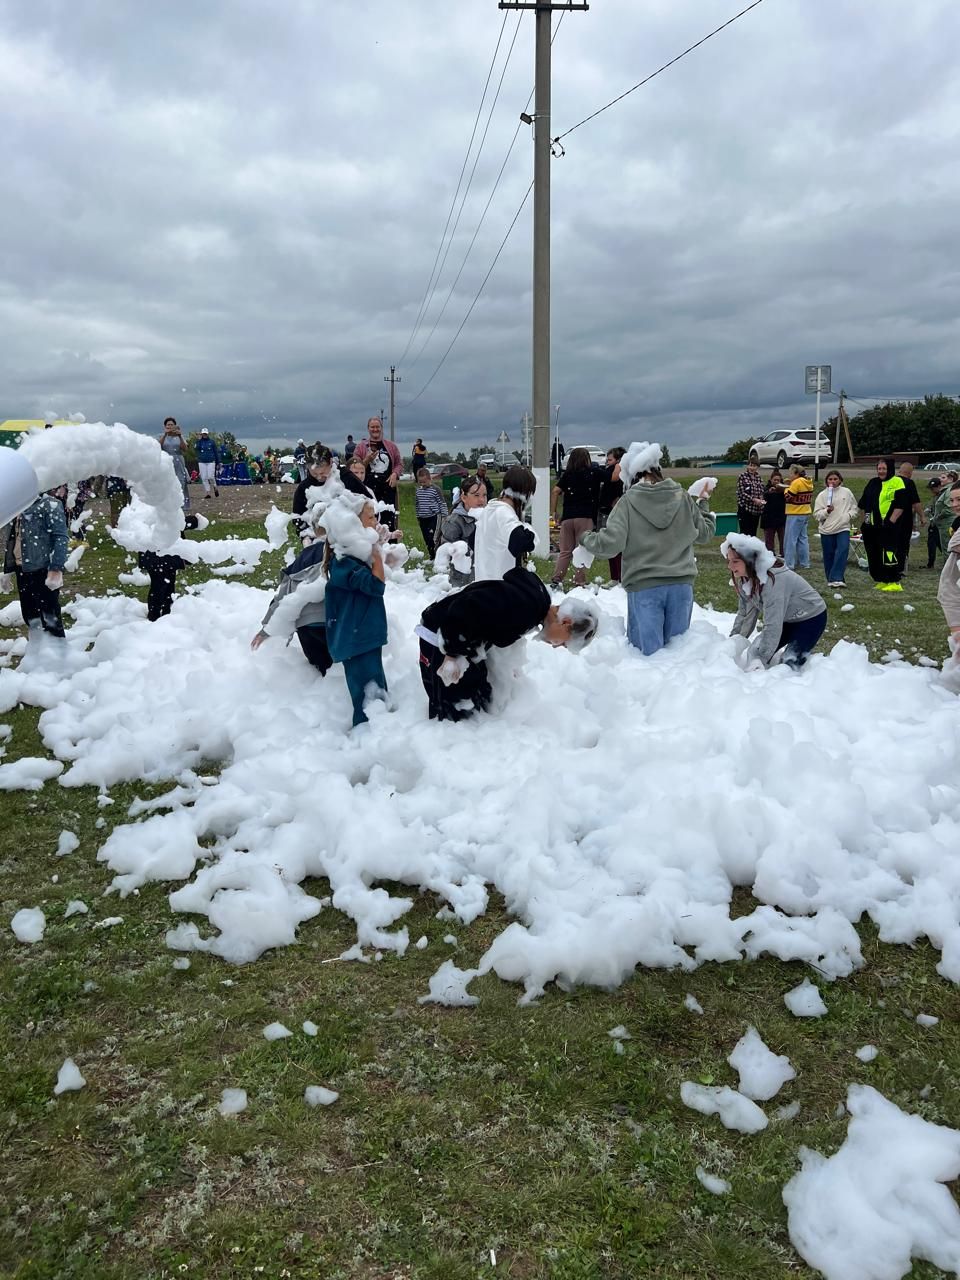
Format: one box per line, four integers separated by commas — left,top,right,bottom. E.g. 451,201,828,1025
580,443,717,655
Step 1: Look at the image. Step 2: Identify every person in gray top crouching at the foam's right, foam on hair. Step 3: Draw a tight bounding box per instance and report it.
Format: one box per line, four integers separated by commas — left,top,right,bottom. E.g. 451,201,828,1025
721,534,827,671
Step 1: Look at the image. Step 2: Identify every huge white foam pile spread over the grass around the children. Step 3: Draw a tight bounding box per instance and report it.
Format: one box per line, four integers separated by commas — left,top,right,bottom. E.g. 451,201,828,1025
0,471,960,1004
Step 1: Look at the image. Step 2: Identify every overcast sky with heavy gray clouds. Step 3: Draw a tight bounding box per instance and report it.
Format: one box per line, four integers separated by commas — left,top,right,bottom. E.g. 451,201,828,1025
0,0,960,457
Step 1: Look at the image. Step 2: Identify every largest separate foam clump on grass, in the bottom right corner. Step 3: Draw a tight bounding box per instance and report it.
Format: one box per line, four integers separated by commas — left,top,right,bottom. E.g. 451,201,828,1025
783,1084,960,1280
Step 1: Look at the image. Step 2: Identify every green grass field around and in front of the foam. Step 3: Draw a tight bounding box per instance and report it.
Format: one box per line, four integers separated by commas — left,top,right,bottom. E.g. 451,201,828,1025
0,477,960,1280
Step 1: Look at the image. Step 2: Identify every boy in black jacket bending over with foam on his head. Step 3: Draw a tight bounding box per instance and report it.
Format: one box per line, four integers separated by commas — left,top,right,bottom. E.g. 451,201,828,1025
416,568,598,721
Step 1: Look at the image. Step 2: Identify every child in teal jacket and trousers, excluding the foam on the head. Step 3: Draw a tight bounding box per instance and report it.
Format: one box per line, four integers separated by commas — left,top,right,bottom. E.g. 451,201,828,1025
324,503,387,727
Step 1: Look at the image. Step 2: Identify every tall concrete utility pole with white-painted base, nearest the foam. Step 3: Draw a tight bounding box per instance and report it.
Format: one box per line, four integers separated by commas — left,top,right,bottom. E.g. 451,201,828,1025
498,0,590,545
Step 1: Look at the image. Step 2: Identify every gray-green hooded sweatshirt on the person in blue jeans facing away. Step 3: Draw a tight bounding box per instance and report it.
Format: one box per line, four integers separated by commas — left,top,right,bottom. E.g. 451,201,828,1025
580,480,717,591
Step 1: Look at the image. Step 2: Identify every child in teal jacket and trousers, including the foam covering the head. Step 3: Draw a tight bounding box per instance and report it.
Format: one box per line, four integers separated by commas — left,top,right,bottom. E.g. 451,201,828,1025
324,494,387,728
